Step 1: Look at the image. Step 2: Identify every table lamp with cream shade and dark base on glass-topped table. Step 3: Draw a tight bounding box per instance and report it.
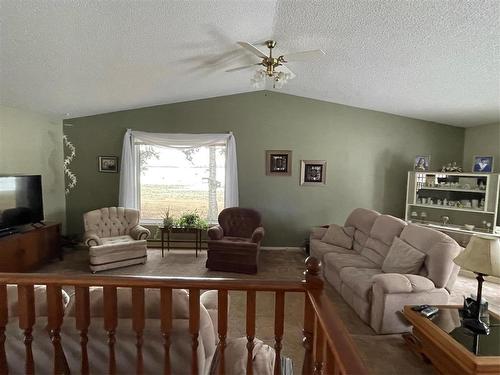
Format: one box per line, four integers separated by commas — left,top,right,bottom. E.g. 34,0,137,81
453,235,500,335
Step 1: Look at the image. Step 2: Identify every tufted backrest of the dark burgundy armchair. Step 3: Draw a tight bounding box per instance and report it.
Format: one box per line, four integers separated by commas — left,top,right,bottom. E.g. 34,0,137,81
219,207,261,238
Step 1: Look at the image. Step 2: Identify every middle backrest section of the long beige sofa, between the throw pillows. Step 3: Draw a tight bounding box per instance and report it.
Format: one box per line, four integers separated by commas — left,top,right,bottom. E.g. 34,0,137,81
361,215,406,266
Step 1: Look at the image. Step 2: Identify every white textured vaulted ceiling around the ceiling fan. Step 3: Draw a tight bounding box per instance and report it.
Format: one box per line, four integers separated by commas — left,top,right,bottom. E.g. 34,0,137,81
0,0,500,126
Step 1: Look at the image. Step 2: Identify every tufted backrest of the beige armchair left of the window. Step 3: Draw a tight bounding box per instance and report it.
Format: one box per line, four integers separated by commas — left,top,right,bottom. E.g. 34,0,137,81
83,207,139,237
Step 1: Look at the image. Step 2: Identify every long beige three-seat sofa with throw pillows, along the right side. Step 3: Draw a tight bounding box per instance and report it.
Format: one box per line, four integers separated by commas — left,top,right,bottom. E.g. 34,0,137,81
310,208,461,334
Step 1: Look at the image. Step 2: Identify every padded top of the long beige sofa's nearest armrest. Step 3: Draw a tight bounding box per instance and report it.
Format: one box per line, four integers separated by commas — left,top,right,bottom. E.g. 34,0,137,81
372,273,436,294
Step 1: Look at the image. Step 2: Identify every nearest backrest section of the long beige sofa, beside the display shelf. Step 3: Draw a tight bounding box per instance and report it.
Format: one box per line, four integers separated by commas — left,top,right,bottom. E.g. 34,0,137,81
400,224,462,291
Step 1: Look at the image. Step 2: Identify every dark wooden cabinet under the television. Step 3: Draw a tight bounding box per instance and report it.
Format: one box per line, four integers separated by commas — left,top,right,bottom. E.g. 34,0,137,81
0,224,62,272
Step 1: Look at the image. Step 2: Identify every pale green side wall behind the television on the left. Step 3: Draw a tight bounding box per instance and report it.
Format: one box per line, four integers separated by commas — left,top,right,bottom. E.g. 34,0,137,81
0,106,66,229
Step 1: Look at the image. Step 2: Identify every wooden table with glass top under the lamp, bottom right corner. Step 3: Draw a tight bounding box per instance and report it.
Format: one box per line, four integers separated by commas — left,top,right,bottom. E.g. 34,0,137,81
403,306,500,374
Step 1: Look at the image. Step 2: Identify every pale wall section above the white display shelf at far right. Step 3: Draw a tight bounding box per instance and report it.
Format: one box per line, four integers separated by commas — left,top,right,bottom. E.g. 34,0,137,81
464,124,500,172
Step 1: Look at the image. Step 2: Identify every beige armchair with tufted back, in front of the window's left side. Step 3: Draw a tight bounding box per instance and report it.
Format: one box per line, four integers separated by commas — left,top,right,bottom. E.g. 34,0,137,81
83,207,151,273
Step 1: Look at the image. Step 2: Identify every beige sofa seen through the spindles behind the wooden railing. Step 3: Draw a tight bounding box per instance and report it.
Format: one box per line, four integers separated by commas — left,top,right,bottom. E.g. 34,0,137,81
5,285,275,375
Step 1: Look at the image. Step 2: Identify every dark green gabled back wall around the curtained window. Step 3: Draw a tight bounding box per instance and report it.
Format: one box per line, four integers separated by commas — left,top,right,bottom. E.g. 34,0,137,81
64,91,464,246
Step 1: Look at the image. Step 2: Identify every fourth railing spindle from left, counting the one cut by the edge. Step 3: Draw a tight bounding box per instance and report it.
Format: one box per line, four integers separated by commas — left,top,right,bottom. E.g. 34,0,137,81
75,286,90,375
